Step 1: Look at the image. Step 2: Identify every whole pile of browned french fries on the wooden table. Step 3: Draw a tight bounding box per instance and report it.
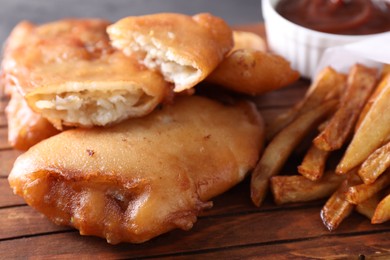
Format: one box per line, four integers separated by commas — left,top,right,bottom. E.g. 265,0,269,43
251,64,390,230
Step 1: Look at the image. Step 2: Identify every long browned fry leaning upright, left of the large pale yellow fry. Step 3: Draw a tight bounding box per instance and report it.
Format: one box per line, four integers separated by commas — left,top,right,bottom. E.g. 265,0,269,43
313,64,377,151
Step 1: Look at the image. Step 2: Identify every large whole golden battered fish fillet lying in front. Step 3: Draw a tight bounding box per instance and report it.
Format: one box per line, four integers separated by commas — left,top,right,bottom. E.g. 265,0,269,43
8,96,264,244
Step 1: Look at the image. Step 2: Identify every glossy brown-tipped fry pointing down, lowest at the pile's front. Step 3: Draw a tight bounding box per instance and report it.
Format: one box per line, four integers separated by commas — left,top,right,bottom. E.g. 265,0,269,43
320,173,359,231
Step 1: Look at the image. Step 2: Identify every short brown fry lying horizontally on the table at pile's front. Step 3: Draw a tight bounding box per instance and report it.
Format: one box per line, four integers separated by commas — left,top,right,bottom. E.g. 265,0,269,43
271,172,345,204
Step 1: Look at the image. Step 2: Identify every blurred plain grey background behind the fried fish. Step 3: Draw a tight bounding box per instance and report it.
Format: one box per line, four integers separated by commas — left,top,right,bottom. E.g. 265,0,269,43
0,0,262,42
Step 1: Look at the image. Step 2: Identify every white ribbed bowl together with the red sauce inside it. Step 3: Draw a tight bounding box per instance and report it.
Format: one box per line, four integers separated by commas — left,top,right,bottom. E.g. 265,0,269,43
262,0,390,78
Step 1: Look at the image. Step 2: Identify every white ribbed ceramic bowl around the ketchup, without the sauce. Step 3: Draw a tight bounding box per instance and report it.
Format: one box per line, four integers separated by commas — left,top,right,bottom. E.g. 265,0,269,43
262,0,386,78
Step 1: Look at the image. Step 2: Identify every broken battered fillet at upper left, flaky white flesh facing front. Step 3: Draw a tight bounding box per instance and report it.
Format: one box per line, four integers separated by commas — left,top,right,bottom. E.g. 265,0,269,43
2,19,170,129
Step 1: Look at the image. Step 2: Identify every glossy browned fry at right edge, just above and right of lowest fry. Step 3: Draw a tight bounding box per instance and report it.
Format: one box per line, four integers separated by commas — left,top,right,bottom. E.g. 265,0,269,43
345,172,390,204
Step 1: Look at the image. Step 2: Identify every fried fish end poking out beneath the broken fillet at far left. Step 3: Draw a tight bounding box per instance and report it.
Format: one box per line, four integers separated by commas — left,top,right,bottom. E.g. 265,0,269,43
5,90,59,150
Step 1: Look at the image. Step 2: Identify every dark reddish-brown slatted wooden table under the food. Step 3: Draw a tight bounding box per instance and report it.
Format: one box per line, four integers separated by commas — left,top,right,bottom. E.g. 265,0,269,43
0,23,390,259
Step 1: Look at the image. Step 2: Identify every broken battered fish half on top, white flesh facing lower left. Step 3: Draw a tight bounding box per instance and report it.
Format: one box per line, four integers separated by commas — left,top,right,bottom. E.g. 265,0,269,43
107,13,233,92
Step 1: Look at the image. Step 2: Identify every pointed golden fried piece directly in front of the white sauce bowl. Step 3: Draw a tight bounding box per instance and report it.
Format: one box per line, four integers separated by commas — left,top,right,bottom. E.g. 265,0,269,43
206,49,299,95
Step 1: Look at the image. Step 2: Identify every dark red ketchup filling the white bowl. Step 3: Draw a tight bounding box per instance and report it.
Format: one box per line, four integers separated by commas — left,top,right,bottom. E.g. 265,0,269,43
276,0,390,35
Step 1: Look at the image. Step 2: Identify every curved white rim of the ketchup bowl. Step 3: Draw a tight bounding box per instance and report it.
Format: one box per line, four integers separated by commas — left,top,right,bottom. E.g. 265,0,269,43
261,0,389,41
